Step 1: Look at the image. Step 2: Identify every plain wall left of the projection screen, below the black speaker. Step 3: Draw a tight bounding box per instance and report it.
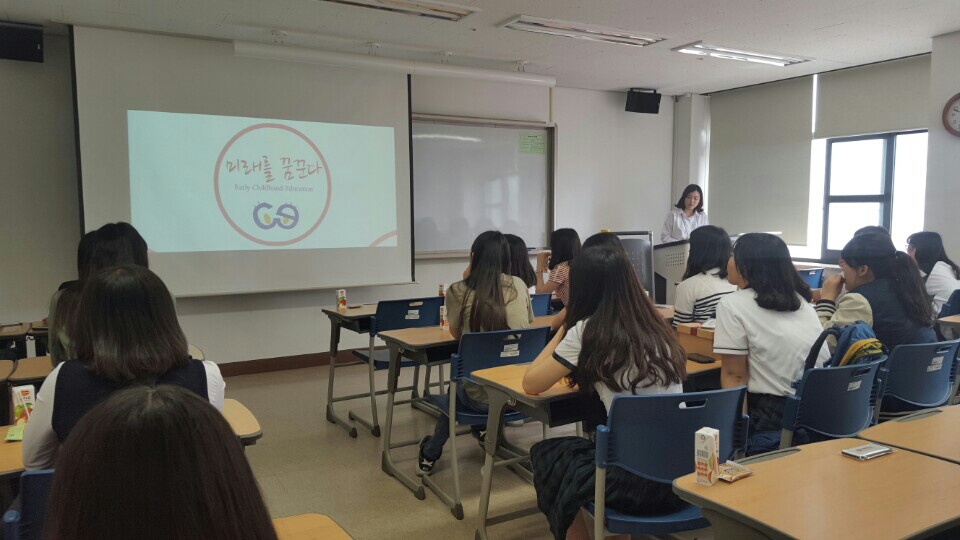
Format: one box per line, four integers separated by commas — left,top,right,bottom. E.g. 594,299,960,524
0,35,80,323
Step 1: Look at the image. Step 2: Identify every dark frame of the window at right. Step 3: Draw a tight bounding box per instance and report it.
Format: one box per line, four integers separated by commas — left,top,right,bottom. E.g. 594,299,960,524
820,129,928,264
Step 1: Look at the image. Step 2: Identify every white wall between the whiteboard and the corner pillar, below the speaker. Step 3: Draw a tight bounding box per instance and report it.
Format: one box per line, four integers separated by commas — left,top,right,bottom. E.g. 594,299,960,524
552,88,673,239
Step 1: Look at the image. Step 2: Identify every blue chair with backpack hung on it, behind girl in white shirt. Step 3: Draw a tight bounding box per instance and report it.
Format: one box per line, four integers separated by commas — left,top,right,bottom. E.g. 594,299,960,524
780,357,886,448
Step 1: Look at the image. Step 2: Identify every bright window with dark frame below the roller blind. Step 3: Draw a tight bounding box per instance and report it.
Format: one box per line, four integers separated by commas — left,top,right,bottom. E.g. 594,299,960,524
820,131,927,262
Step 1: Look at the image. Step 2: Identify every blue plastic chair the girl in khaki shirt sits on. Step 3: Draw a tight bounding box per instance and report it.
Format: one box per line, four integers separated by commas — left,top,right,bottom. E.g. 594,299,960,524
421,326,550,519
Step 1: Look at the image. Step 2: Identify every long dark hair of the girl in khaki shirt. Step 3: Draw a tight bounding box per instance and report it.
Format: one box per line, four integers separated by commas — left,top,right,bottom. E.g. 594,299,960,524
461,231,517,332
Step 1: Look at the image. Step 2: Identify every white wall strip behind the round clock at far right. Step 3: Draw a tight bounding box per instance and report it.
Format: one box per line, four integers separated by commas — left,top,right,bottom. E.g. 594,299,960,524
924,32,960,260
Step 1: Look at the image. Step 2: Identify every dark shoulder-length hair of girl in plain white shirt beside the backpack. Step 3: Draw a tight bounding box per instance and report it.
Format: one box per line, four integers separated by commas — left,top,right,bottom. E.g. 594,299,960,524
733,233,813,311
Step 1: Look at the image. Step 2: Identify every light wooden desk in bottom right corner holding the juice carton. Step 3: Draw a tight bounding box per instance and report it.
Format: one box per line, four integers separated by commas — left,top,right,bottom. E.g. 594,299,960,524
673,434,960,540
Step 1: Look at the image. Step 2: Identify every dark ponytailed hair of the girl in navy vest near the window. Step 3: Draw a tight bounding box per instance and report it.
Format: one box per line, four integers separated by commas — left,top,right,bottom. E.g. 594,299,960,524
840,233,934,326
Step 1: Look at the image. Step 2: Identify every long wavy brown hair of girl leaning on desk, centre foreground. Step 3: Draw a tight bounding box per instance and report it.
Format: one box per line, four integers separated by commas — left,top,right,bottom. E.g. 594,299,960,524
564,246,687,392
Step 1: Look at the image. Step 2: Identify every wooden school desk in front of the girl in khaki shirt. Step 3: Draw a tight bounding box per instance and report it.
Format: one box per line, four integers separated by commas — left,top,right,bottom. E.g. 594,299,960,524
378,315,553,500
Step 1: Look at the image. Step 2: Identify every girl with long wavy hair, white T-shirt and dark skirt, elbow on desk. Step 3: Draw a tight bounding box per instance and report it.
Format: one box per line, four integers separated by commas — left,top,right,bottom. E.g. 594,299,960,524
523,246,686,539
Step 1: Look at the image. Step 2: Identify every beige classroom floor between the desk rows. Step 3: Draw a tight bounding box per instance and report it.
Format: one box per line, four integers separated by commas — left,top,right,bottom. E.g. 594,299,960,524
226,367,712,540
